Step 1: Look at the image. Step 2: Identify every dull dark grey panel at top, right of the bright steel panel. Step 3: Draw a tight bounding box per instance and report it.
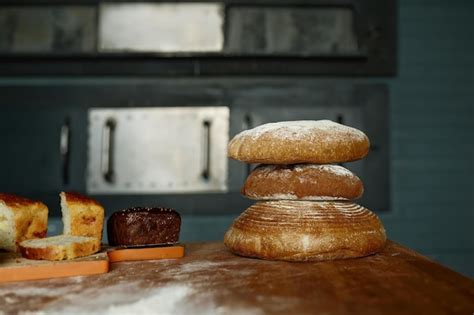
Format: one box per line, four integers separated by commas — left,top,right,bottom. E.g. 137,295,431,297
226,6,360,56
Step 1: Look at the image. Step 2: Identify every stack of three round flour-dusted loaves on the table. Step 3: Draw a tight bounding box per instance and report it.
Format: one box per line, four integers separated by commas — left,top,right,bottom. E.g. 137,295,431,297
224,120,386,261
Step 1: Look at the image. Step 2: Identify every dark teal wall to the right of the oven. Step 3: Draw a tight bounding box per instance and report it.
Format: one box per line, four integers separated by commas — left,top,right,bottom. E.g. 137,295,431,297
384,0,474,276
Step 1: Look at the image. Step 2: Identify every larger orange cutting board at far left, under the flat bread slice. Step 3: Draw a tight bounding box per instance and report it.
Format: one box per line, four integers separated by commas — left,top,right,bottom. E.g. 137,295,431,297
0,252,109,283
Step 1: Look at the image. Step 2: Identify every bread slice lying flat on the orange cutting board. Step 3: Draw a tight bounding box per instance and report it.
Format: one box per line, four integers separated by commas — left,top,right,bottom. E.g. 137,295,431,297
20,235,100,260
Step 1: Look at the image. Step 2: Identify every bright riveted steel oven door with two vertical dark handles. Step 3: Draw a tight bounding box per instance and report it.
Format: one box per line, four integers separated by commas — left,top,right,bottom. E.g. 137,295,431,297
87,106,229,194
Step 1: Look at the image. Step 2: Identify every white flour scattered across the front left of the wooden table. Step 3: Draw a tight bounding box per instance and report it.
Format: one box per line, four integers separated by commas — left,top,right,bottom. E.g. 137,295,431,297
7,260,263,315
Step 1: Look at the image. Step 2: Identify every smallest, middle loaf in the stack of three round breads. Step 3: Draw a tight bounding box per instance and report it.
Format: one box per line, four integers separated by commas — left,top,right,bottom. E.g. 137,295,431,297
241,164,364,200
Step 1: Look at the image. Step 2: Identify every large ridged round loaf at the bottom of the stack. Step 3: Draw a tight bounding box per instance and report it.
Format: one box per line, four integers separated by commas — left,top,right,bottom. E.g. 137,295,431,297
224,201,386,261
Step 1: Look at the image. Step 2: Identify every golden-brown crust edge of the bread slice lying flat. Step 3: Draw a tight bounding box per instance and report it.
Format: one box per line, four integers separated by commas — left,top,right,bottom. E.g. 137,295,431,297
20,236,100,260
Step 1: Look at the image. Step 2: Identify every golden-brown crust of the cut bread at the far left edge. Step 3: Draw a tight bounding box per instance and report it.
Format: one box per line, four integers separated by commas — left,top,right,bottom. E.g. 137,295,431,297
0,193,48,251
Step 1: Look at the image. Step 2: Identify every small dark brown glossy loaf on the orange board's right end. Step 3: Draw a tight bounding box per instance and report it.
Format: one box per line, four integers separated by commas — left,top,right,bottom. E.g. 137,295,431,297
107,207,181,246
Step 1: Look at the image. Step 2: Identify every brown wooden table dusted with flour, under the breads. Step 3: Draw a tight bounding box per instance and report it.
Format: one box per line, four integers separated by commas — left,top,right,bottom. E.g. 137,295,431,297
0,242,474,315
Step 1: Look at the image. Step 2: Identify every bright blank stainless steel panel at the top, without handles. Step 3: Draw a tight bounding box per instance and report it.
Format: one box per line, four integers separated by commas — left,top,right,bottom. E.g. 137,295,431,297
99,3,224,53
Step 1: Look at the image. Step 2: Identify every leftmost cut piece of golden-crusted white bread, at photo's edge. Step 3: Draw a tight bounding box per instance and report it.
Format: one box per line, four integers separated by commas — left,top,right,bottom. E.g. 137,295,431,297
0,193,48,251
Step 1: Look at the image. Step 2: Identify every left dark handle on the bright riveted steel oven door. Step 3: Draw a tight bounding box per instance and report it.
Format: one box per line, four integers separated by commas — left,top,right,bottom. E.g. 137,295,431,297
101,118,117,183
